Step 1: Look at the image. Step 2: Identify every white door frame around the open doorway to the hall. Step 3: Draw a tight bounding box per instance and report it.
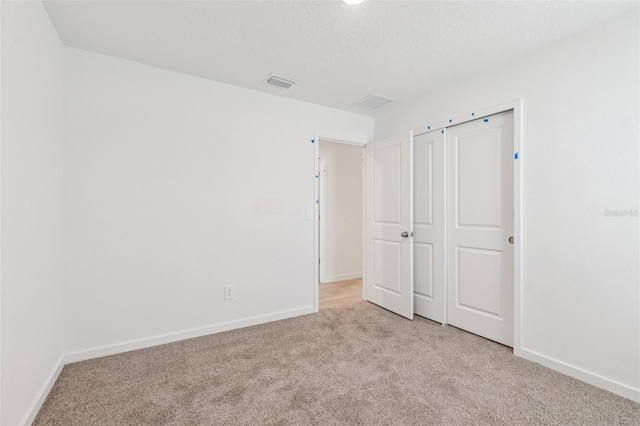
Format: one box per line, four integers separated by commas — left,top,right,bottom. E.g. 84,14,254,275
311,132,369,312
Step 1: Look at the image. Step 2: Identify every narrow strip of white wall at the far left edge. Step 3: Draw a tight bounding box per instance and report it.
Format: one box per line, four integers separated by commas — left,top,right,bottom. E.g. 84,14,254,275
0,2,64,425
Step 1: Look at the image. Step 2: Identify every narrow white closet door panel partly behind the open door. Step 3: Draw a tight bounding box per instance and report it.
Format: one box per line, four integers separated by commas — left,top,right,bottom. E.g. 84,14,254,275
413,130,445,324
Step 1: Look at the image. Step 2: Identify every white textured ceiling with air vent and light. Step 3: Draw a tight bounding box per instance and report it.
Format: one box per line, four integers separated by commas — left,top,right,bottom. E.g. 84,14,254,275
45,1,638,114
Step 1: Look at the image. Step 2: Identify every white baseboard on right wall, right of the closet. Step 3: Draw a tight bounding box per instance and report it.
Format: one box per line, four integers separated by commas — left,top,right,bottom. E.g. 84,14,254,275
521,348,640,402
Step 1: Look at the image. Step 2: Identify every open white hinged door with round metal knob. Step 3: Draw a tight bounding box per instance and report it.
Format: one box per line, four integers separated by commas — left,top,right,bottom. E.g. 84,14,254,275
364,132,413,319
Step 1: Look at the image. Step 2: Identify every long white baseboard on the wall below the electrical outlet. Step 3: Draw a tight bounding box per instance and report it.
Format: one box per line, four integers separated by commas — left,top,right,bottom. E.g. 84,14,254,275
64,306,315,364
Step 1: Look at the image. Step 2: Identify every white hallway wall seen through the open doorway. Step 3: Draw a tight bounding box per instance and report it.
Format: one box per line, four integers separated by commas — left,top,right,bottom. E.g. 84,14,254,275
319,141,363,282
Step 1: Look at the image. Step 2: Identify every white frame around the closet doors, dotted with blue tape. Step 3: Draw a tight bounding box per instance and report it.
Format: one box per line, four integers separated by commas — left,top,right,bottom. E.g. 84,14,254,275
413,99,523,357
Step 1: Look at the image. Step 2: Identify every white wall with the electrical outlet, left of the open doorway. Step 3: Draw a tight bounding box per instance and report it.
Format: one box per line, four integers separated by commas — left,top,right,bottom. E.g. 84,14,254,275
65,48,373,359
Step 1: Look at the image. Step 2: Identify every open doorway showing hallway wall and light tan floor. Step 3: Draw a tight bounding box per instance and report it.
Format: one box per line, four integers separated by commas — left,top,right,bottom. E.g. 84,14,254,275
318,139,364,309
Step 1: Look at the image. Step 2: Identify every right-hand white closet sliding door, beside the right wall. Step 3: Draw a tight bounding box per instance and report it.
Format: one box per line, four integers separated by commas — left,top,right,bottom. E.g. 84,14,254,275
446,112,513,346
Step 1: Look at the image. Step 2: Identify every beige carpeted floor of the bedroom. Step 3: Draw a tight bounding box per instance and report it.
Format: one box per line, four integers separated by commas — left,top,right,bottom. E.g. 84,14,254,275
35,302,640,426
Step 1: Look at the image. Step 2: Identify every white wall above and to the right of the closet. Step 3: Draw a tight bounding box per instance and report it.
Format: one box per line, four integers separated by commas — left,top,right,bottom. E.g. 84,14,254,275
375,11,640,400
